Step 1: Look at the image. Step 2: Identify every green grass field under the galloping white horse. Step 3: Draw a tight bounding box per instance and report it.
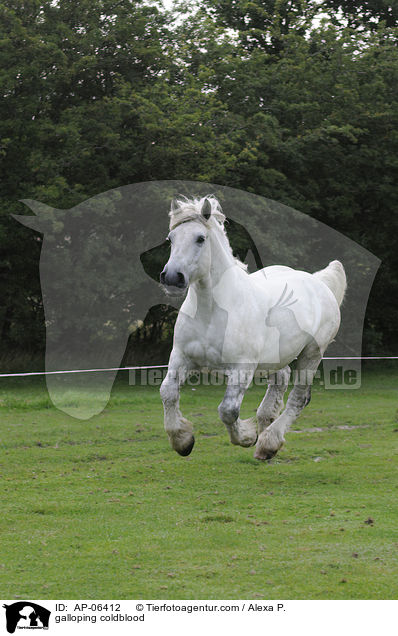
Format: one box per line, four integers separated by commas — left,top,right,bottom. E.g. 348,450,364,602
0,367,398,599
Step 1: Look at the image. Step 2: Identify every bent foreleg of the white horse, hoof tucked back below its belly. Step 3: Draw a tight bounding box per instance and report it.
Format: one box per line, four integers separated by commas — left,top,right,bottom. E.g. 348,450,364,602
218,369,257,446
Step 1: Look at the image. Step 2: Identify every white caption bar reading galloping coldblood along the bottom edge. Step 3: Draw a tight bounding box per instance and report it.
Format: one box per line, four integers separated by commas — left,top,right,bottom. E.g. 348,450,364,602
1,600,398,636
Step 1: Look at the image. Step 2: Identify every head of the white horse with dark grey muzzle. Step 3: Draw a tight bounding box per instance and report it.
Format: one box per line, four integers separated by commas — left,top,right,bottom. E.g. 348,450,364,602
160,197,218,295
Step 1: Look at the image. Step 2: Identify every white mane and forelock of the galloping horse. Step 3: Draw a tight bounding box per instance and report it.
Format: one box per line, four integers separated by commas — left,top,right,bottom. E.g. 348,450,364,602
169,194,247,270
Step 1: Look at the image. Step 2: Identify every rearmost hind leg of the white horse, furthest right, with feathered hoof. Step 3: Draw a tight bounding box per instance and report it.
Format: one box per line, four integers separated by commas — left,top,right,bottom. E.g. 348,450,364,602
254,344,322,460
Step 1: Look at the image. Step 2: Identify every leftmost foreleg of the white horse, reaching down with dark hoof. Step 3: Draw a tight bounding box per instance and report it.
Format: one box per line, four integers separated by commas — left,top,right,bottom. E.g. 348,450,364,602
160,352,195,457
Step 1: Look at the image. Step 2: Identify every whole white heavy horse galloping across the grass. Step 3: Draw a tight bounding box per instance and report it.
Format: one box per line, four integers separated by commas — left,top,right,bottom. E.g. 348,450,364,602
160,196,346,460
